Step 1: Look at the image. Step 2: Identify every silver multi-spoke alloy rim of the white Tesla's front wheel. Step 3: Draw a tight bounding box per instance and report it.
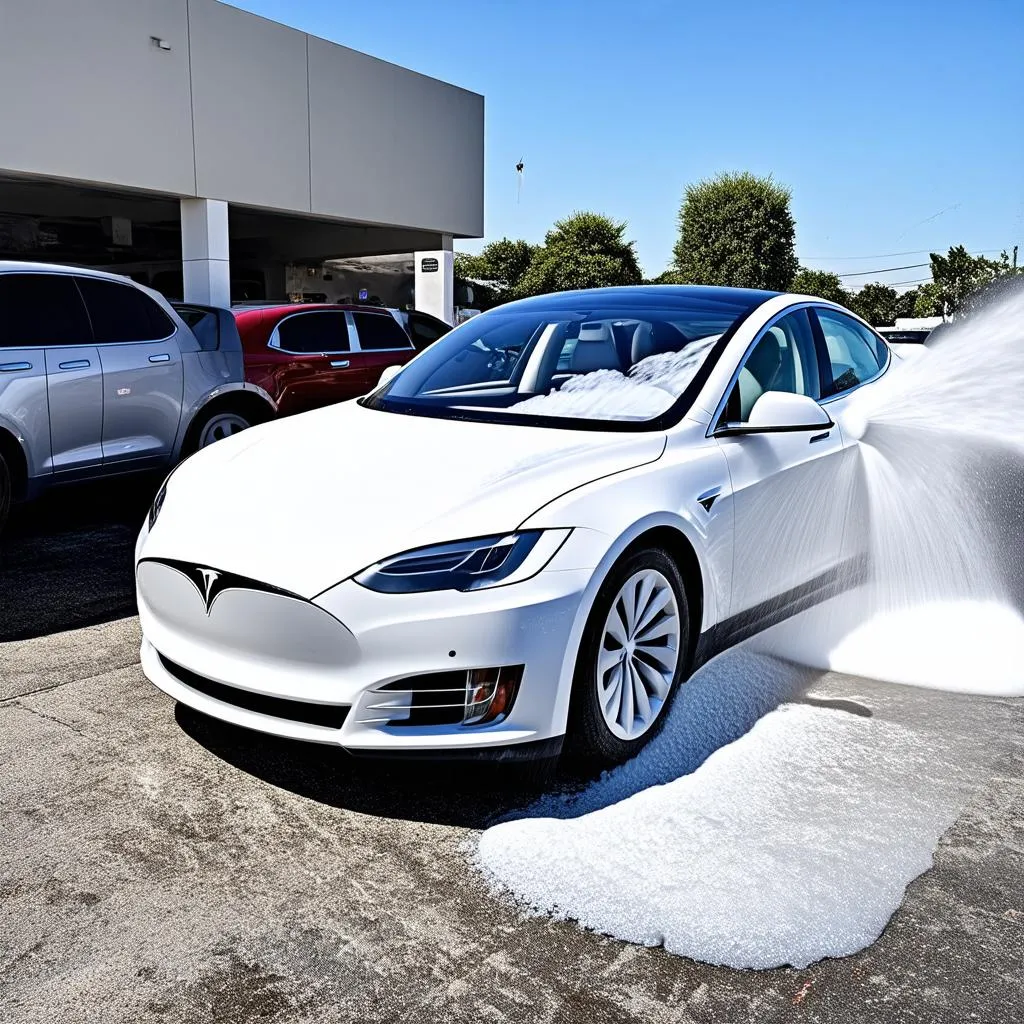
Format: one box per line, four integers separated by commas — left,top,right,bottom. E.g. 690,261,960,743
596,568,680,740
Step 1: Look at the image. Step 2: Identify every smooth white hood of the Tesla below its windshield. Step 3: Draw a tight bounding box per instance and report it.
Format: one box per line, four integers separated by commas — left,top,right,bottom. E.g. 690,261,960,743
144,401,666,598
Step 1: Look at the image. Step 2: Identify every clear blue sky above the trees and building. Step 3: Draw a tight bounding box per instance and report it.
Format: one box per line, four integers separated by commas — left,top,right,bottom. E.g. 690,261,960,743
237,0,1024,286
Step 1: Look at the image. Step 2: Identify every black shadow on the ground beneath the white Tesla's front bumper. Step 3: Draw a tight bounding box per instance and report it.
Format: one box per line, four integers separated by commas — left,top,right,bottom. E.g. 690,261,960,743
174,703,565,828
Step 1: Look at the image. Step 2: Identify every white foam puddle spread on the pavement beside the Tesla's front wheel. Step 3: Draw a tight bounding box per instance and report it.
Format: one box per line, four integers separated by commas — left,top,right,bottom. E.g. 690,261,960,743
477,655,978,968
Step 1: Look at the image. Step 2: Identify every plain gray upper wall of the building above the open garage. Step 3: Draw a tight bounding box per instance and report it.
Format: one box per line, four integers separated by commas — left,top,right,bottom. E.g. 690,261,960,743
0,0,483,237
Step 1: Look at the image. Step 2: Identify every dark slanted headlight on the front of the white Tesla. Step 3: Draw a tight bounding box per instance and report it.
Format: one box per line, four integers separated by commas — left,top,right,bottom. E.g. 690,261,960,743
353,529,571,594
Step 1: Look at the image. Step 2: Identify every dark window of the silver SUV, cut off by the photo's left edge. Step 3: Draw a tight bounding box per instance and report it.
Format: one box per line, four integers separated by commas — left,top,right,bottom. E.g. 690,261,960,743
0,273,92,348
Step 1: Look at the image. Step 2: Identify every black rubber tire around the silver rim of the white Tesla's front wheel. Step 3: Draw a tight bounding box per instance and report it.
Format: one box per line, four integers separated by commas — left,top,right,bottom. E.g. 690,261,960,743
565,548,692,768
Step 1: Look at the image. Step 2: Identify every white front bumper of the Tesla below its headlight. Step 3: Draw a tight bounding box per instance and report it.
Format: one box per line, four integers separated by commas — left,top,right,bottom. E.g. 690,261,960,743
137,561,591,756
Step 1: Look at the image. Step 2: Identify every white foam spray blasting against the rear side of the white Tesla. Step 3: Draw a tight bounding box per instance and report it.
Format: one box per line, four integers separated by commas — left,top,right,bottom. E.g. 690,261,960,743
761,281,1024,695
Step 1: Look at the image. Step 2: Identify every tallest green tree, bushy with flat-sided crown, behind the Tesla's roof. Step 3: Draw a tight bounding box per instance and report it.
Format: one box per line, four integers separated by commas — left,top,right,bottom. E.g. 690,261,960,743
674,171,800,291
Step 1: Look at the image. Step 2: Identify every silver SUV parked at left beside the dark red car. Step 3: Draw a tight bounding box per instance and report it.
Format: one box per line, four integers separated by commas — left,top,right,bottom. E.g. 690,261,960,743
0,261,275,528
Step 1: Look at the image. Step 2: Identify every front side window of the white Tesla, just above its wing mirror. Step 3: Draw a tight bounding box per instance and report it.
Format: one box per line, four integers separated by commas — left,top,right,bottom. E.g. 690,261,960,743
720,309,821,425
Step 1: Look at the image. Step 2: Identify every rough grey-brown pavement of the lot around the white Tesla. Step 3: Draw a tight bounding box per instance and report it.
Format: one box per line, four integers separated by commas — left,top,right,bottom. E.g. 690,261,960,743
0,487,1024,1024
